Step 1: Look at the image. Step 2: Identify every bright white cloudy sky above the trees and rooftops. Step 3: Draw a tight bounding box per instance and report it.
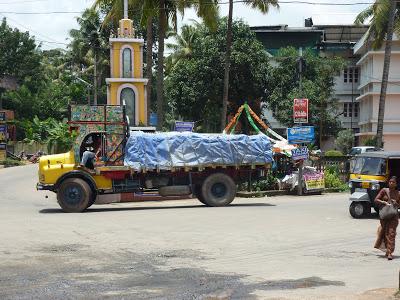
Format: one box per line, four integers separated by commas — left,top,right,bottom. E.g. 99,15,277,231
0,0,372,49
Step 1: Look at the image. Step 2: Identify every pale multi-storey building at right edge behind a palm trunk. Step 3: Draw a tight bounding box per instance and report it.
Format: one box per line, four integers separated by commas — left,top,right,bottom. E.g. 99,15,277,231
354,35,400,151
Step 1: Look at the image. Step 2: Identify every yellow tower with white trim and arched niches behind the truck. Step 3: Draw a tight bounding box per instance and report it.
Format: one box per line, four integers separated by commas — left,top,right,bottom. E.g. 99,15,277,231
106,1,148,126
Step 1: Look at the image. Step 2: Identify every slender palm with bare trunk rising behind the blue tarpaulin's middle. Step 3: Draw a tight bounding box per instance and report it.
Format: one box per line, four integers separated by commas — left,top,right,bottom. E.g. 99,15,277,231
221,0,279,130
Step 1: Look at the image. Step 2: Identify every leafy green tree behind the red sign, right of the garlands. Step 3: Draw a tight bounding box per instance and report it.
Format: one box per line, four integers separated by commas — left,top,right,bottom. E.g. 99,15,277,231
267,47,344,145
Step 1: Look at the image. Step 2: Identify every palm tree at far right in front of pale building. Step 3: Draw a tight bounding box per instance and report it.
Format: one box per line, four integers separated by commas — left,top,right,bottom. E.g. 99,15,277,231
355,0,400,148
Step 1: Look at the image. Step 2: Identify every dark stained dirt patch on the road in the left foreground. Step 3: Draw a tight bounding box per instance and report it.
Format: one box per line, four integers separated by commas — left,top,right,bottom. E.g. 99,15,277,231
0,244,344,299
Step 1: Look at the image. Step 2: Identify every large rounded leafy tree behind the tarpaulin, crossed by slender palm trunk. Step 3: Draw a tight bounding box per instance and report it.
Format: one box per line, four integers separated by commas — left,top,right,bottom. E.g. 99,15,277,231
166,19,270,132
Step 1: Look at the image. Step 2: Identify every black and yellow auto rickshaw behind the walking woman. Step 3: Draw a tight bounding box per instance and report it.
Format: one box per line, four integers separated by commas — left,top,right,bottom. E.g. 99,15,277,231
349,151,400,219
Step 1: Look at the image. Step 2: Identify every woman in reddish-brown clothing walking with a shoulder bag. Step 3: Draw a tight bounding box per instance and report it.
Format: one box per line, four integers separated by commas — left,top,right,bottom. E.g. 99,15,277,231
374,176,400,260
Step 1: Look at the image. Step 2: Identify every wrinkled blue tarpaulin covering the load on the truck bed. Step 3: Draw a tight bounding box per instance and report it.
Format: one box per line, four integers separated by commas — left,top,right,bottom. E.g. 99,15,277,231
124,132,272,171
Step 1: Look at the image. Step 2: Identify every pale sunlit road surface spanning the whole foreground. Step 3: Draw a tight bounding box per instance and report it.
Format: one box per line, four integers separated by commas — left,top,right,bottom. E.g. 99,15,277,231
0,165,400,299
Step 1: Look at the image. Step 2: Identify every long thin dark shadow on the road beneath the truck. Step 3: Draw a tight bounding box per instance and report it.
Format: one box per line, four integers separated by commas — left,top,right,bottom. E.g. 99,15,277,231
39,203,276,214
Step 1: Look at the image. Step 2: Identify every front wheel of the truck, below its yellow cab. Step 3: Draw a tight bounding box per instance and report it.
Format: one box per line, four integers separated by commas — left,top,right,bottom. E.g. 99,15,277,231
57,178,94,213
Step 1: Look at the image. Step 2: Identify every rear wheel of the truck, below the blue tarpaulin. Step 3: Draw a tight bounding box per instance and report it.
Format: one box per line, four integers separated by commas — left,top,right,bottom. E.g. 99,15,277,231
201,173,236,206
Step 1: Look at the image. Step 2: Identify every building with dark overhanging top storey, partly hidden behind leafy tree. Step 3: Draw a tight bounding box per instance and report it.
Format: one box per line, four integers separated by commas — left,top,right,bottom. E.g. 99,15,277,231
252,19,368,150
